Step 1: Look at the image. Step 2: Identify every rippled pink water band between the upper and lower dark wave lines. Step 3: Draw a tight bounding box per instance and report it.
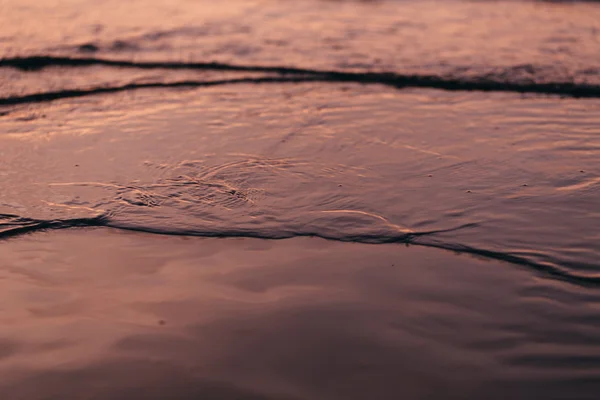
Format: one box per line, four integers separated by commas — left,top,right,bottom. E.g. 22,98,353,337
0,83,600,284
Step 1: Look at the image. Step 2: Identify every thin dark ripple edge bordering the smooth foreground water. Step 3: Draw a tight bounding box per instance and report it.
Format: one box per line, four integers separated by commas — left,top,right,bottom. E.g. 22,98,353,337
0,214,600,287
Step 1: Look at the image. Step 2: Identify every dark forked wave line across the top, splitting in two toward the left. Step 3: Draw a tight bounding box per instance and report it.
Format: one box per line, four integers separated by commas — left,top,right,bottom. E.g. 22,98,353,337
0,56,600,106
